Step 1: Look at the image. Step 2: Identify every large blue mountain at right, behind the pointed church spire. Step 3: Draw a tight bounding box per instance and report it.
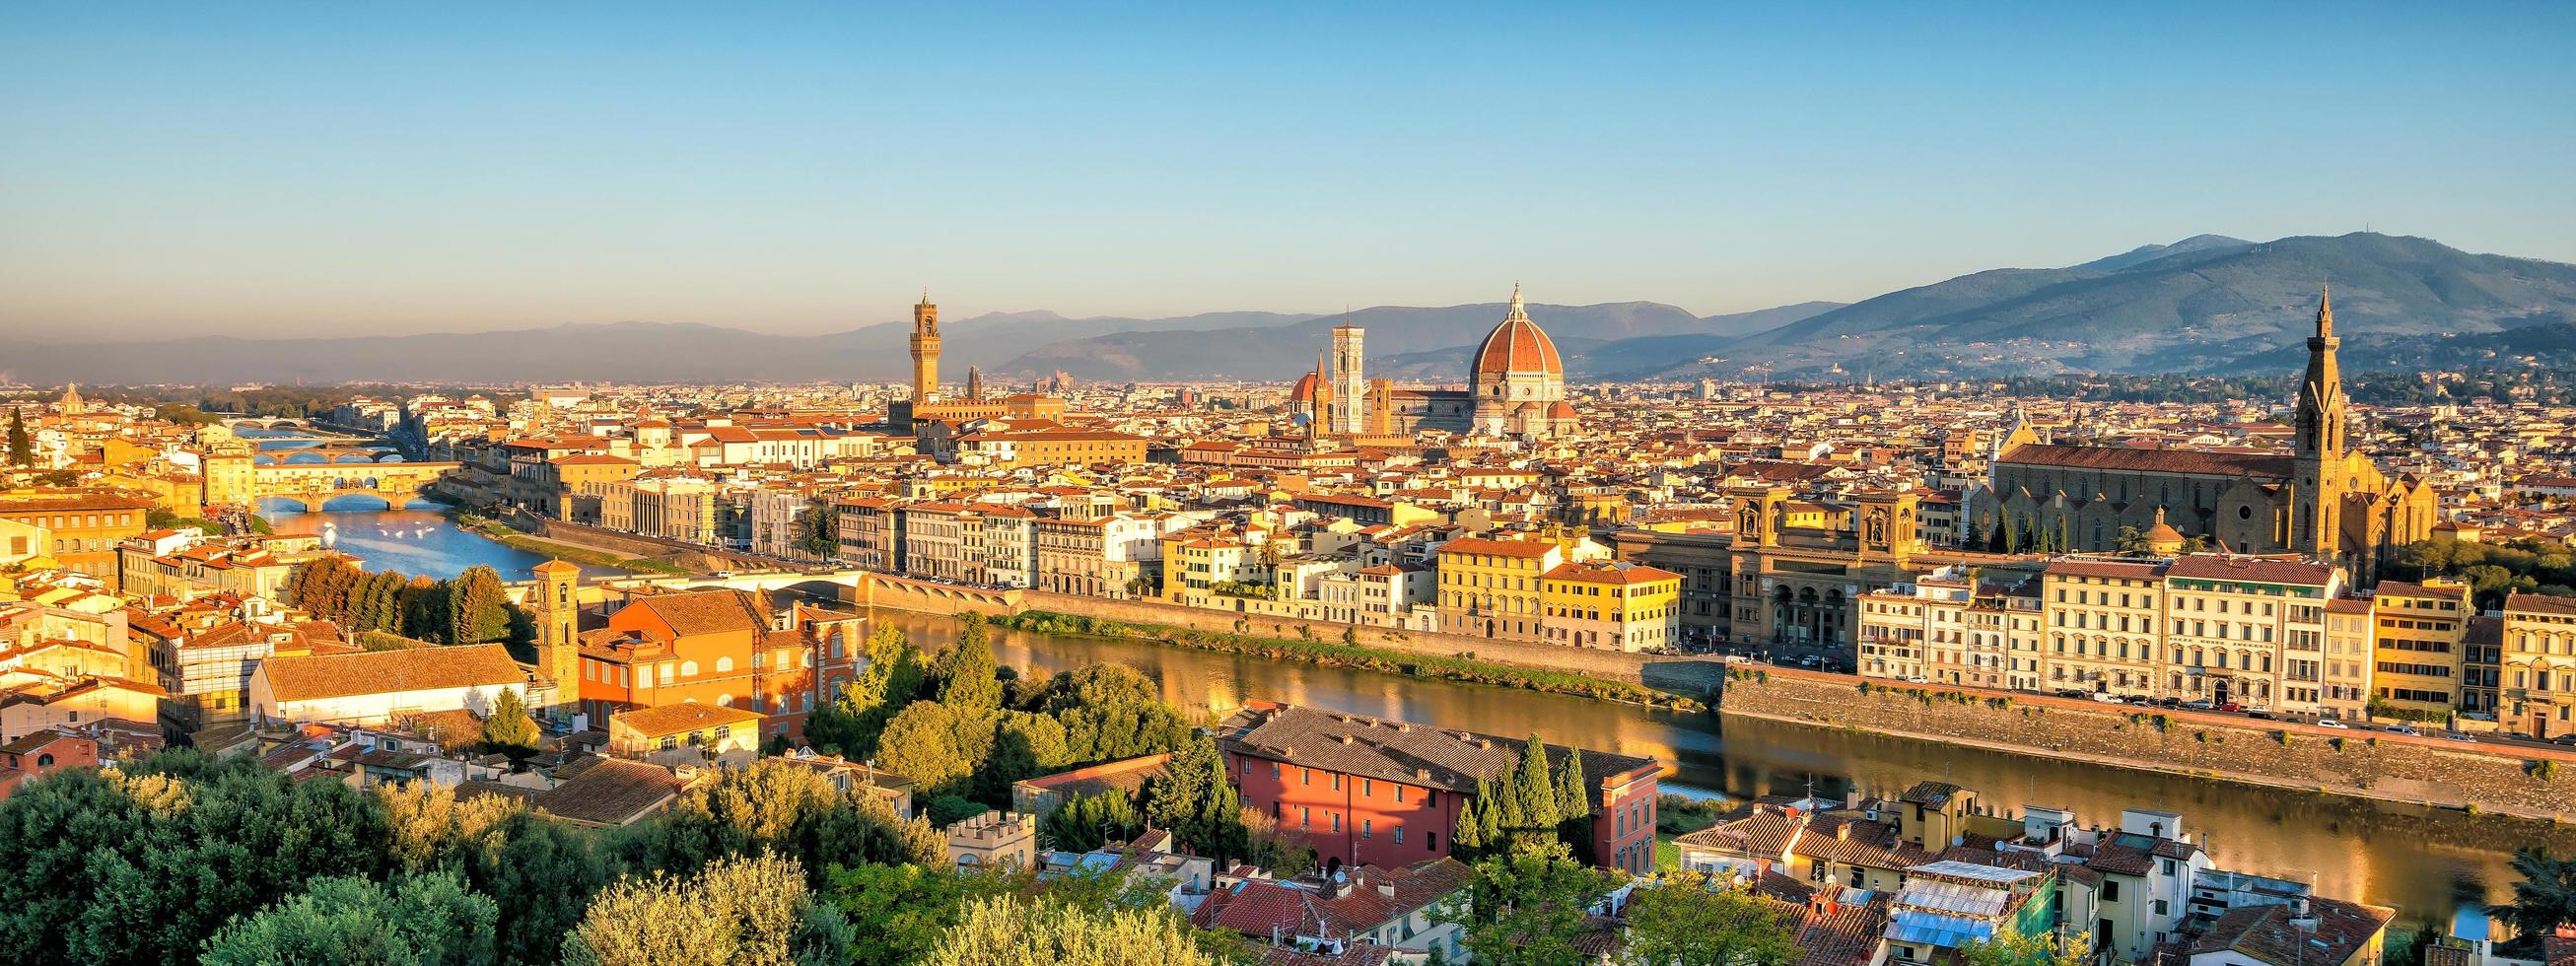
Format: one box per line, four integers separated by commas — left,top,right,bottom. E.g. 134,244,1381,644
1669,232,2576,377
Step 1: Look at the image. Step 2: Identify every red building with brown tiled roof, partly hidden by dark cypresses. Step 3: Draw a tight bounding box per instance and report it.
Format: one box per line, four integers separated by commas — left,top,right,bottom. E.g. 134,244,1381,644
1216,701,1661,873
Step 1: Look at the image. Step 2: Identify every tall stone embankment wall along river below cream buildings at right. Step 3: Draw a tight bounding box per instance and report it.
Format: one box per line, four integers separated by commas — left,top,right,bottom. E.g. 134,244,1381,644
1718,667,2576,822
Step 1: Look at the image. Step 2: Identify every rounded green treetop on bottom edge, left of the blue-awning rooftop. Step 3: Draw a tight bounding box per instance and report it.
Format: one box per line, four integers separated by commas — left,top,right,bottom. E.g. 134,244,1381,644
1626,870,1803,966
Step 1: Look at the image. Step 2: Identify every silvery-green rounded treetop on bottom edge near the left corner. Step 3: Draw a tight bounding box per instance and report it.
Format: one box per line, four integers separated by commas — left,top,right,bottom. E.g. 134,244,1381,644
198,873,500,966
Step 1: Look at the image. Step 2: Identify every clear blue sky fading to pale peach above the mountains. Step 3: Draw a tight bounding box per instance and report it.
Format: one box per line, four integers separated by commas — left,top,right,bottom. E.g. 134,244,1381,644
0,3,2576,337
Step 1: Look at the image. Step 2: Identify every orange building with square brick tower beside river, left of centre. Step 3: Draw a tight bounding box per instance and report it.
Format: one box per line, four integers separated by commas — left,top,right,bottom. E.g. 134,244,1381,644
536,562,866,736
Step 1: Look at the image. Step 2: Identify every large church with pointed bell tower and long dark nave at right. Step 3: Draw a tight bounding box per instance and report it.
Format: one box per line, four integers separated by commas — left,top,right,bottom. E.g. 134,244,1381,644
1960,291,2437,580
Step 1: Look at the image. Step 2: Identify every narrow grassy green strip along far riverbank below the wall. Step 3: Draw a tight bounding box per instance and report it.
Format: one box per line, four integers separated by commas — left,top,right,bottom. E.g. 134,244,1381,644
995,610,1701,711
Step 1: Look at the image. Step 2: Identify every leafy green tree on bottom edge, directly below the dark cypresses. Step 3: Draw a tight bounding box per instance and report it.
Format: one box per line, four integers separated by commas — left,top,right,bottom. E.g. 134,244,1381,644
1442,843,1610,966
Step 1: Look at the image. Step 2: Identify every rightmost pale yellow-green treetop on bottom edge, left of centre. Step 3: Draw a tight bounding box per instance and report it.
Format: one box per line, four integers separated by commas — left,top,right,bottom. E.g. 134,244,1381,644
925,896,1216,966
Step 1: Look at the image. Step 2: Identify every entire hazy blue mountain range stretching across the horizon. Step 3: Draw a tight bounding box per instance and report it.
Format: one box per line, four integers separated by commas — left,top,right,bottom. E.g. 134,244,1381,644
20,232,2576,383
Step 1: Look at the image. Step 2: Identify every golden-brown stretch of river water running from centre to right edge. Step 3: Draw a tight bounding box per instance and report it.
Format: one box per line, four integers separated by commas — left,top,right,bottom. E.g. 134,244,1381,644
875,610,2576,923
